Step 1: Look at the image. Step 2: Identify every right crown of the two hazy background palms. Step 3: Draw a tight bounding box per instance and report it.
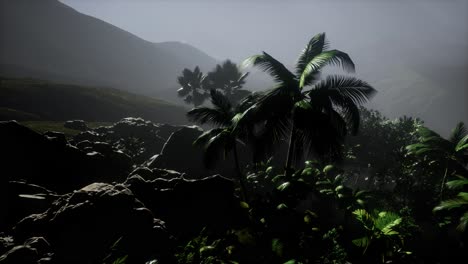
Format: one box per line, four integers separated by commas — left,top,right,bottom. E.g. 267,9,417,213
206,60,251,105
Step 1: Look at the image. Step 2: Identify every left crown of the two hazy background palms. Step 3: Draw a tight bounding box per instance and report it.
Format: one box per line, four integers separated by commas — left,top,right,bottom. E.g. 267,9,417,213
177,66,208,107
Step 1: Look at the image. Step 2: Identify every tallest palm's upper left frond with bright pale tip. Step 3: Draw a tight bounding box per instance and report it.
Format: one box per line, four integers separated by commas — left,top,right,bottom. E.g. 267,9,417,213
242,52,297,86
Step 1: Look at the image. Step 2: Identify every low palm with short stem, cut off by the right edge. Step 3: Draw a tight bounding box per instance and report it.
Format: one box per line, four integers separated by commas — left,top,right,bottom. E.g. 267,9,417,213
406,122,468,199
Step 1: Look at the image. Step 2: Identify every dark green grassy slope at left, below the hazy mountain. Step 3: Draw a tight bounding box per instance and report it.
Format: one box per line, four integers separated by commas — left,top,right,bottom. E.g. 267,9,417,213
0,78,190,124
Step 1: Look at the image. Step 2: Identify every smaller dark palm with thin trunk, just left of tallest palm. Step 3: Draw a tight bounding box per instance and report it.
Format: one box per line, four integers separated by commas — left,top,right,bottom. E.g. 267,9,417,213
187,89,254,199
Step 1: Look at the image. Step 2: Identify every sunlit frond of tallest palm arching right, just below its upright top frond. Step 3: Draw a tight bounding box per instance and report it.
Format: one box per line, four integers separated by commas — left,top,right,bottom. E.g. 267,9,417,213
299,50,355,88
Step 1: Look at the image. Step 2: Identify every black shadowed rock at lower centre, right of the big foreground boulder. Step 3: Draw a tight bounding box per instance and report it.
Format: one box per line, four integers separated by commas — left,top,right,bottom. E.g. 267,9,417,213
124,175,244,237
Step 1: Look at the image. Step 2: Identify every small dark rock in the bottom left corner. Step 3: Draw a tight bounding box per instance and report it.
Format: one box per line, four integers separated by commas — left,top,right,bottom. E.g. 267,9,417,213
0,237,51,264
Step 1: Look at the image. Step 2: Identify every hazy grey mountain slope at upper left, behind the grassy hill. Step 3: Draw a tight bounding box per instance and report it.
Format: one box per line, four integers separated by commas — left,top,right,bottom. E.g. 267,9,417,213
0,0,216,100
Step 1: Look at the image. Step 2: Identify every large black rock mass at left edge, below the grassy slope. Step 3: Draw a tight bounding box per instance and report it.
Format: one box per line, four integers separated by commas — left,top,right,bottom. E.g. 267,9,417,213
0,121,131,193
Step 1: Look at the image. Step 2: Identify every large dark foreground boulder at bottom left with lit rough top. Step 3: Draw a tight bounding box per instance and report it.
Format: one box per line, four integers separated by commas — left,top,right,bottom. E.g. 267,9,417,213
13,183,171,264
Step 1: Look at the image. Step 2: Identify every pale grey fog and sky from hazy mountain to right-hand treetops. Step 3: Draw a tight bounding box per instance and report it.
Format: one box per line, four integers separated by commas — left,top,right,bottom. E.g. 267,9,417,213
62,0,468,133
